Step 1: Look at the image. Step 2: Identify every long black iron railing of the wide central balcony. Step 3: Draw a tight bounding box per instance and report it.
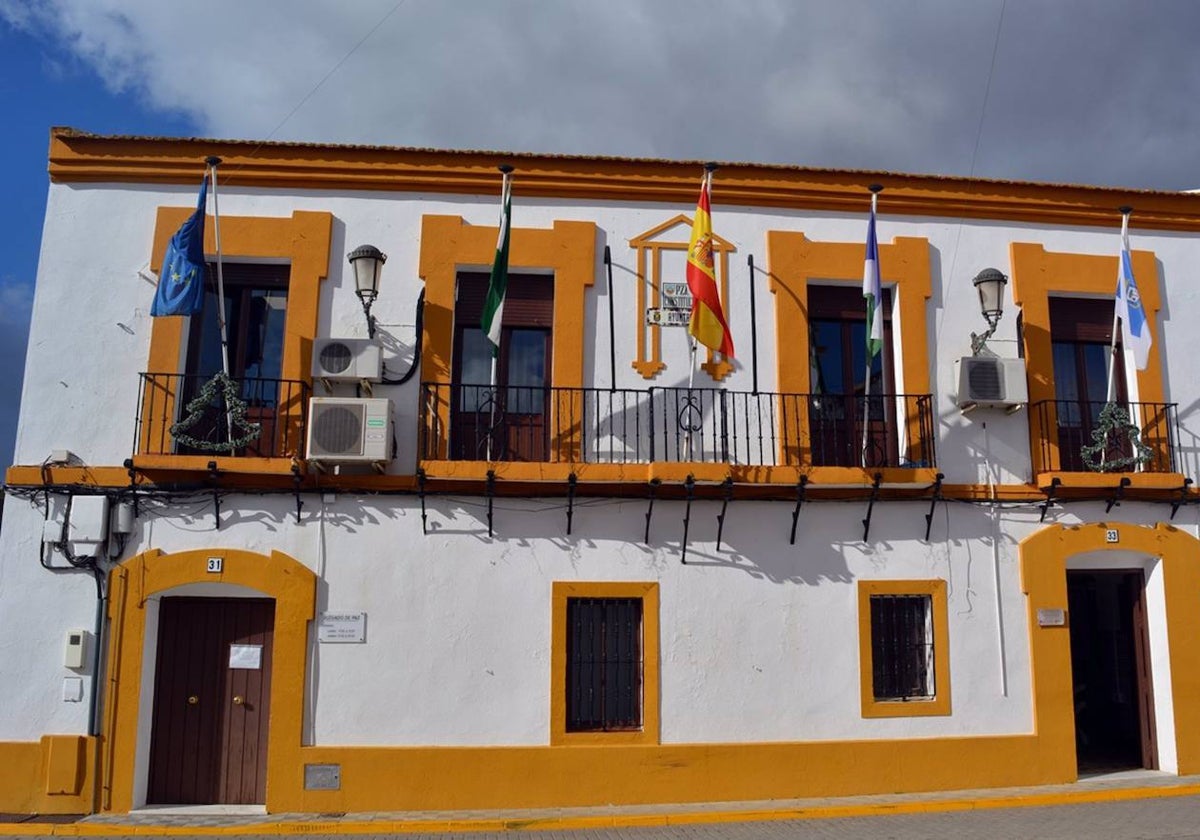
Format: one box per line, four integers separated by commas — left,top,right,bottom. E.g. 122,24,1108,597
420,383,934,467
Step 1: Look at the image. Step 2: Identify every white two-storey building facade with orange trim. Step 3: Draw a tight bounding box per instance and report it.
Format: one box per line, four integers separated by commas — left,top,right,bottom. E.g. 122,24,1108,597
0,128,1200,812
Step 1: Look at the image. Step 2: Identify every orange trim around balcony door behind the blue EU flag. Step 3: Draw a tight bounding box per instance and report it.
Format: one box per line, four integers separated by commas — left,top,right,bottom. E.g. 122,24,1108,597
139,208,334,458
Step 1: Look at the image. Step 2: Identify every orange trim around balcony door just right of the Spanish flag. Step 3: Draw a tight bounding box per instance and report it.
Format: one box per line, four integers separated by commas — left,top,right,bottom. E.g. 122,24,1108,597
767,229,932,463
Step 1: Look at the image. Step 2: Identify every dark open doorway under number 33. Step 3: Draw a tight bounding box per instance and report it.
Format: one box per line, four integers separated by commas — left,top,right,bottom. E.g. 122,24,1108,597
1067,569,1158,773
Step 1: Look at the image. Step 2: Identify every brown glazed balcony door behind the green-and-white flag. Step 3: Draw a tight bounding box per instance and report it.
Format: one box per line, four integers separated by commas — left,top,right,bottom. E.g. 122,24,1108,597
450,274,554,461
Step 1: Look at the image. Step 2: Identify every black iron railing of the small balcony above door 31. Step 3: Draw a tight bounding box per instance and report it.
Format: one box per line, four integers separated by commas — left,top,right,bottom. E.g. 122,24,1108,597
133,373,308,457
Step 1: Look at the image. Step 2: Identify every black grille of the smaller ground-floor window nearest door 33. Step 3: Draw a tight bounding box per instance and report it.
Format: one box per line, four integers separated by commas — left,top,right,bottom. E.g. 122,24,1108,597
871,595,937,700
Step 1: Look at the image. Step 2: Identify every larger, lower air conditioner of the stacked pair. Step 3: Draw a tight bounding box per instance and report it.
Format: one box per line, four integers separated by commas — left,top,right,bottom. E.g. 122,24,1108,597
306,397,392,464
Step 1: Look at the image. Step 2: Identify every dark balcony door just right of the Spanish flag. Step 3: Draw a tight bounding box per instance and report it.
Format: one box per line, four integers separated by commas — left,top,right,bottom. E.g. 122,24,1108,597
809,284,896,467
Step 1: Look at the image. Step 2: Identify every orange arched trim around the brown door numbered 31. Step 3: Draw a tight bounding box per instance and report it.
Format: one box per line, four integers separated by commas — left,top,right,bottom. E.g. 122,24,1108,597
100,548,317,811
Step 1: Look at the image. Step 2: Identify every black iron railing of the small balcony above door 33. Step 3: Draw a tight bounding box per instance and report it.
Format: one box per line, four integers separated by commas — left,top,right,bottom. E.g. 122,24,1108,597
1031,400,1180,473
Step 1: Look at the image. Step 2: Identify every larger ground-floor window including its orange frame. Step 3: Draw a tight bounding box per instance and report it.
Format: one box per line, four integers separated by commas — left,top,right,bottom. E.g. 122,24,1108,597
550,582,659,744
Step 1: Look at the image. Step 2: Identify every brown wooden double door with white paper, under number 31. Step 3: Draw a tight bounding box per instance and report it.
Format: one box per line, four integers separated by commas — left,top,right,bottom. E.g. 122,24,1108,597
146,598,275,805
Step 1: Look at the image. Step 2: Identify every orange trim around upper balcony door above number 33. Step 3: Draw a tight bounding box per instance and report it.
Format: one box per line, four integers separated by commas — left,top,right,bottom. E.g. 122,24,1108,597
1009,246,1166,475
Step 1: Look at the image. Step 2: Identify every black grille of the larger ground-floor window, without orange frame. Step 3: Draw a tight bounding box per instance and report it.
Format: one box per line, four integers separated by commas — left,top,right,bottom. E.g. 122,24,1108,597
566,598,642,732
